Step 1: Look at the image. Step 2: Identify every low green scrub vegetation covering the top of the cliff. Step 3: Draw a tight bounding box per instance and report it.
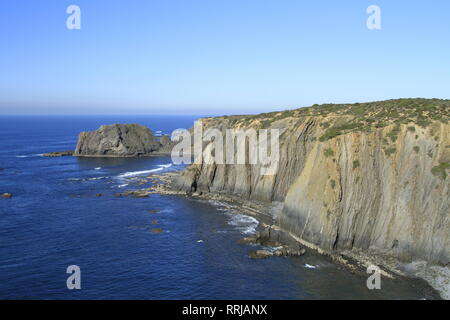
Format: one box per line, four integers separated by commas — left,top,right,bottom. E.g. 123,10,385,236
216,98,450,141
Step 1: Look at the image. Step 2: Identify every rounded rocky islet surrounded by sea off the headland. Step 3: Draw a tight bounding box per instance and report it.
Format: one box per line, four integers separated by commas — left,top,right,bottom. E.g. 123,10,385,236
73,124,171,157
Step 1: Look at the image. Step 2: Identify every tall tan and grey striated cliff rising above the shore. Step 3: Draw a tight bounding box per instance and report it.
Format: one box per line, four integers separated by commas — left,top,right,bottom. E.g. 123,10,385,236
175,100,450,265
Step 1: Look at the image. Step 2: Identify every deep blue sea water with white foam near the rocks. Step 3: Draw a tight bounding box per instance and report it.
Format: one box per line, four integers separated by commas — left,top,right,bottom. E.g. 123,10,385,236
0,116,436,299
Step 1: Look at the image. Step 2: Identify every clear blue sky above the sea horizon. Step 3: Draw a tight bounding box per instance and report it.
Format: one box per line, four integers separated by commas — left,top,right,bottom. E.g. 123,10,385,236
0,0,450,115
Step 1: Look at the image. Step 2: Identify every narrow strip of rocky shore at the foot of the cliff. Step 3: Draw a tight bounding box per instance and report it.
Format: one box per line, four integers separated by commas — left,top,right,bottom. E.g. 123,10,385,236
136,171,450,300
